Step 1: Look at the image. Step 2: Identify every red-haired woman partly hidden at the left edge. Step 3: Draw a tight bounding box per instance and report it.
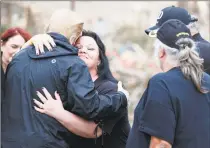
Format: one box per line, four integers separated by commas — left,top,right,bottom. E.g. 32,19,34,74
1,27,31,97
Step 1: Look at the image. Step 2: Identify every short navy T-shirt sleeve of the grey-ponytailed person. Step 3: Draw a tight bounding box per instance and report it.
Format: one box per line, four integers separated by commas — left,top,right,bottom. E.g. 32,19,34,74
138,78,176,144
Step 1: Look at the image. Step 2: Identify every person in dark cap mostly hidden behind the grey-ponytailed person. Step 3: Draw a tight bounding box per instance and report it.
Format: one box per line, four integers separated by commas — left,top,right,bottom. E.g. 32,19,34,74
145,6,210,75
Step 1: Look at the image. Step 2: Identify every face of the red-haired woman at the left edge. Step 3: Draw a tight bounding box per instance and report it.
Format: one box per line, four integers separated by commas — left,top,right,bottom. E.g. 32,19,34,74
1,35,25,60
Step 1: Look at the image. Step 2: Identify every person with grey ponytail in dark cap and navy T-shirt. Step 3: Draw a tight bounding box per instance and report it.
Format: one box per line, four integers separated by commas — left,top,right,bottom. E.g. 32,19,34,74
126,19,210,148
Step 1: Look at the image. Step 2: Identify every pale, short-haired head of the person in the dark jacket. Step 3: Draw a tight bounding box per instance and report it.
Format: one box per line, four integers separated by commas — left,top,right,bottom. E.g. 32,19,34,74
45,9,84,42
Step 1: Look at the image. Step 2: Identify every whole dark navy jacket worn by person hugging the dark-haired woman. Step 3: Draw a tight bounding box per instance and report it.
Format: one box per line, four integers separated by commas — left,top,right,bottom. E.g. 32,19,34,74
2,33,127,148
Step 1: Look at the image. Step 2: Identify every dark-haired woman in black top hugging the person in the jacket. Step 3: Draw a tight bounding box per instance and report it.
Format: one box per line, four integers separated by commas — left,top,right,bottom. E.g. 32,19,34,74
26,31,130,148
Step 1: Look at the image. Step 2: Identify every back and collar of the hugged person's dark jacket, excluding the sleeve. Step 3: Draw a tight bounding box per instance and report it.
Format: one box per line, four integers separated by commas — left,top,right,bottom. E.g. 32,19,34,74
2,33,81,148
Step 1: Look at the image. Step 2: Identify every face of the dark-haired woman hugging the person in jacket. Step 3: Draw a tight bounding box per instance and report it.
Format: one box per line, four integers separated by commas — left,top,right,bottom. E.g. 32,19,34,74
76,36,100,71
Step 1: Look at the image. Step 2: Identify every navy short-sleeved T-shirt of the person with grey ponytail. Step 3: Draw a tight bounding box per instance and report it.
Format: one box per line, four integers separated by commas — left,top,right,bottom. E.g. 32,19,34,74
126,68,210,148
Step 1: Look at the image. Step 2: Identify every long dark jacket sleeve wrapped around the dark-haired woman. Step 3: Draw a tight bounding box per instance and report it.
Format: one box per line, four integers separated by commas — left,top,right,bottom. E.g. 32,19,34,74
67,61,127,120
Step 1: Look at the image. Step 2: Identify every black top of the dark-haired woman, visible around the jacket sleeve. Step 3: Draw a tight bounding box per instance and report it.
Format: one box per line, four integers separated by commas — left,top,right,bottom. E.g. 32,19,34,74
70,77,130,148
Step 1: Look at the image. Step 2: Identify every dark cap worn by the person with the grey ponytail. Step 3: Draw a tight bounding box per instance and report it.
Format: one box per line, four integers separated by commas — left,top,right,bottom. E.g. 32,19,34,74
157,19,192,49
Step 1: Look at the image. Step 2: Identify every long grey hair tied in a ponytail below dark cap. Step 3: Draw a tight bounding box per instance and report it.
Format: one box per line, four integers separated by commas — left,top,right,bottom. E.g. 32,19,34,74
155,38,208,93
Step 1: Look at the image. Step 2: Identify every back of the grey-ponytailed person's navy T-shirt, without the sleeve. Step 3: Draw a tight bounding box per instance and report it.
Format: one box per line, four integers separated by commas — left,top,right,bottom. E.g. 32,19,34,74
156,68,210,148
